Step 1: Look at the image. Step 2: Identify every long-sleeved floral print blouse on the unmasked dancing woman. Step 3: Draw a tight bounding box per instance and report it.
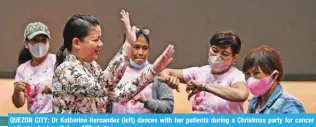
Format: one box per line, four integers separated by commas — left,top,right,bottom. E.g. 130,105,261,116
53,48,155,113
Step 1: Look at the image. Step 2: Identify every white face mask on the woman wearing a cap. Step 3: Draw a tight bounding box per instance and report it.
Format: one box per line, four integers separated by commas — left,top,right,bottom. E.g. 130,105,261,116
28,42,48,58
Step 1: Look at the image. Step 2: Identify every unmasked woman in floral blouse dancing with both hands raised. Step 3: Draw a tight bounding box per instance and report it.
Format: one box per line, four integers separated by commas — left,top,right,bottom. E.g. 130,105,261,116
53,10,174,113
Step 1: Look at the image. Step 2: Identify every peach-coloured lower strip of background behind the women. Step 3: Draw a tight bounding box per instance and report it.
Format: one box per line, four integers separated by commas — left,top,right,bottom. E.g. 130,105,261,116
0,79,316,115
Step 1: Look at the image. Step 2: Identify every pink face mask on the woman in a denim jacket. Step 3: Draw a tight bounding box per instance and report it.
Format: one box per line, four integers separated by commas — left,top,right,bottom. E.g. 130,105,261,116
247,70,279,96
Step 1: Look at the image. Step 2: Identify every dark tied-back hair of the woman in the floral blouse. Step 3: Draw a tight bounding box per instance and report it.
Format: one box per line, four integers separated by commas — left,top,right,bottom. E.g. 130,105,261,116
56,14,100,67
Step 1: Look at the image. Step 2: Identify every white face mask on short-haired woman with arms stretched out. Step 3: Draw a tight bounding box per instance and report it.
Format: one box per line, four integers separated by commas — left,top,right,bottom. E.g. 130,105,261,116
208,56,230,71
